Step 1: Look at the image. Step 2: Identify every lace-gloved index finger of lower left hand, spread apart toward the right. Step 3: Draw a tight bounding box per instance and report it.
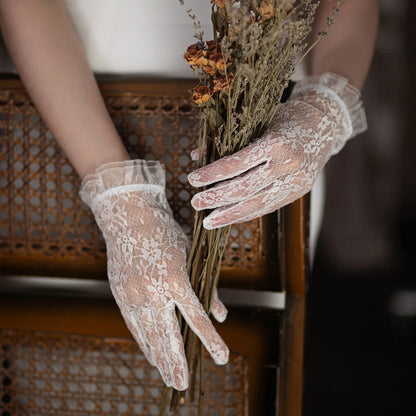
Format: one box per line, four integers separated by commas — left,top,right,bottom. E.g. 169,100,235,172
175,285,230,365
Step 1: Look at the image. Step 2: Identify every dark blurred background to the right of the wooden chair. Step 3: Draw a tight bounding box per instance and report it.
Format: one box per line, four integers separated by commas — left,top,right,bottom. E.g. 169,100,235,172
305,0,416,416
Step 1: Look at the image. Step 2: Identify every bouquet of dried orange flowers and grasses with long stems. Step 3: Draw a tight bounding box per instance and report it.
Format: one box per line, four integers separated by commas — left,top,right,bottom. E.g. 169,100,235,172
160,0,343,416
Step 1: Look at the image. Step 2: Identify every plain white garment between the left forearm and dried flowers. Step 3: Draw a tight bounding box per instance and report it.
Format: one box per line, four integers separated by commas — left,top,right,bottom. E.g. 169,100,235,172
65,0,212,78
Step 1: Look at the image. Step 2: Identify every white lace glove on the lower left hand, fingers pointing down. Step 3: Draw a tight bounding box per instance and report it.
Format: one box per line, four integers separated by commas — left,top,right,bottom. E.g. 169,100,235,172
80,160,229,390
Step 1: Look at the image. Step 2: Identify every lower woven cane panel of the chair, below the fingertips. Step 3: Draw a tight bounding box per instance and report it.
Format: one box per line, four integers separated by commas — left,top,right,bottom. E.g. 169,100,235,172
0,330,248,416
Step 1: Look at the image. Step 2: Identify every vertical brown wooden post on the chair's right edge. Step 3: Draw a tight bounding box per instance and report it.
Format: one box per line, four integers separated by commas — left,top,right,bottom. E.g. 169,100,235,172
278,195,310,416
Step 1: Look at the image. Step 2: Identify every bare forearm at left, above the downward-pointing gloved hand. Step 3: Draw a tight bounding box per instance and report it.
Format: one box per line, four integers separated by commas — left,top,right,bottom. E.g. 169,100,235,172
0,0,128,176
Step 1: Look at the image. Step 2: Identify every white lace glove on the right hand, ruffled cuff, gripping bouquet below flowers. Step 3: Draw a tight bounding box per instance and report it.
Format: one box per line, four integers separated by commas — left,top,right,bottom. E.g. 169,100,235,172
188,73,367,229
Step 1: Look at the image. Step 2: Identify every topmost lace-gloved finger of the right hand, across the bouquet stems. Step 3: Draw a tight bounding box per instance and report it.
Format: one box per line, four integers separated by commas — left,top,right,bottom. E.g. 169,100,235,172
188,143,266,187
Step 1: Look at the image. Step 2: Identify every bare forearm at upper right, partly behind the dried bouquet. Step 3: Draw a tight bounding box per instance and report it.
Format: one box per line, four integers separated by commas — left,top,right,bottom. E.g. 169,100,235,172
310,0,379,89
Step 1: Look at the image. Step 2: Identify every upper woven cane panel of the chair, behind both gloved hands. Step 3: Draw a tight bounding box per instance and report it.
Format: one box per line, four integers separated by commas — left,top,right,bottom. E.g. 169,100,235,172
0,89,261,270
